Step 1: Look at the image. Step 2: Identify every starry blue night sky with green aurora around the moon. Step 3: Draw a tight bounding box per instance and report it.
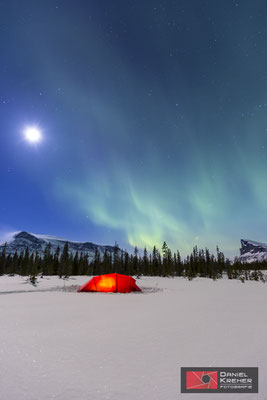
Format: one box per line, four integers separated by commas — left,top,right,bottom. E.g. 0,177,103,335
0,0,267,257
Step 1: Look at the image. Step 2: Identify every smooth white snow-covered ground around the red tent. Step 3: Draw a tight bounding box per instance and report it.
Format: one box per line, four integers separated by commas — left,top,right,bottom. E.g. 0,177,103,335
0,276,267,400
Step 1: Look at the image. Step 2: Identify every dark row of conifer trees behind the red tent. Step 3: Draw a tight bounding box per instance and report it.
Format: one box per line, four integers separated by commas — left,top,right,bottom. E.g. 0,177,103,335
0,242,267,282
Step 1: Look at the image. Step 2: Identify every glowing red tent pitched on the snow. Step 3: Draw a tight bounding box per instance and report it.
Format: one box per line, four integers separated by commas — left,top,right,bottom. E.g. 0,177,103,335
78,274,141,293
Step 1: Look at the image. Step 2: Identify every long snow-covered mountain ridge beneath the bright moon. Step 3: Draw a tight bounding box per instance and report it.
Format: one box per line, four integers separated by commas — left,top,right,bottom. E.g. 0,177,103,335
0,231,117,259
